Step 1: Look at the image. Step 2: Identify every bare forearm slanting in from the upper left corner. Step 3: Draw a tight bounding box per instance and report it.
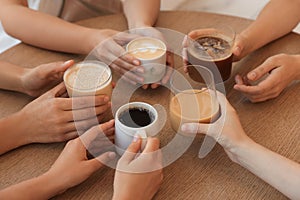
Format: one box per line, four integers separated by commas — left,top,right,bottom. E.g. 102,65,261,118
0,4,93,54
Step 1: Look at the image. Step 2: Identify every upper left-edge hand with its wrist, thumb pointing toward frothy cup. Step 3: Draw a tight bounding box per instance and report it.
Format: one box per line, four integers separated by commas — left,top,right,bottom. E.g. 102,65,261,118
0,60,74,97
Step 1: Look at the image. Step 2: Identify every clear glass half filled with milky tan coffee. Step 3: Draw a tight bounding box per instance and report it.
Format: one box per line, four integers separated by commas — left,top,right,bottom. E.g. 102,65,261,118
169,65,219,133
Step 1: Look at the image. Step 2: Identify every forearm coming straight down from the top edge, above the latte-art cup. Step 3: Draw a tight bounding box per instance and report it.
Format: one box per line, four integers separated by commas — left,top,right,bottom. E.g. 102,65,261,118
123,0,160,29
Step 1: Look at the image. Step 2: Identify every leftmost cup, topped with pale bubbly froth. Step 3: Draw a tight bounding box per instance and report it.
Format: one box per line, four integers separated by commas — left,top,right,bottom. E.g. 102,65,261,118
64,60,112,97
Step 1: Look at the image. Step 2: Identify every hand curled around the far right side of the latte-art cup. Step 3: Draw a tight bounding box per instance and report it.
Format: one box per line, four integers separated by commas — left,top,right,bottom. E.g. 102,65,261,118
130,27,174,90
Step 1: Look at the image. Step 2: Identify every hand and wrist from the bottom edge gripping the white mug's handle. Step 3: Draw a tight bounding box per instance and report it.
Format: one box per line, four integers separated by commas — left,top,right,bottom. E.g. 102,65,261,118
113,137,163,200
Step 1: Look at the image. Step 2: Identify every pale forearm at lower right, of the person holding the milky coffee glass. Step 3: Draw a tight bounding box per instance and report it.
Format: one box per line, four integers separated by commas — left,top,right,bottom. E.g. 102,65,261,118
236,141,300,199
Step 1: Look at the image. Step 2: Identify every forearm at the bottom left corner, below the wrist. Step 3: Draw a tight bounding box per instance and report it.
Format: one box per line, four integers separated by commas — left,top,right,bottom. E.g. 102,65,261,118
0,173,65,200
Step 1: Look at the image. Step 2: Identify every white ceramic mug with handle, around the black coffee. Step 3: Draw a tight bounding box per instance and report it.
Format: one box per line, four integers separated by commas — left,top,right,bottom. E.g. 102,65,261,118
115,102,159,155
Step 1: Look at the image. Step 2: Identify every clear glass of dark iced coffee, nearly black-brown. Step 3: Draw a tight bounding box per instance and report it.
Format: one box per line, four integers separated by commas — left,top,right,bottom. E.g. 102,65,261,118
187,26,235,83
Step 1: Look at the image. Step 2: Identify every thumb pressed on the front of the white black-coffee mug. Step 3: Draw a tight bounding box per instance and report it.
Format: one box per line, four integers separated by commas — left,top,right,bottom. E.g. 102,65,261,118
120,136,142,164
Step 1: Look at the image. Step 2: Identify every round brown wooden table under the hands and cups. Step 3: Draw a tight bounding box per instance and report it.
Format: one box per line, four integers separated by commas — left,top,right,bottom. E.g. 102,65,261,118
0,11,300,199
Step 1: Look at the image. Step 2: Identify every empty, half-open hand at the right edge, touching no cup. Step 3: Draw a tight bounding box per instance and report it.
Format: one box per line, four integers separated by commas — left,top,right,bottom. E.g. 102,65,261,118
234,54,300,102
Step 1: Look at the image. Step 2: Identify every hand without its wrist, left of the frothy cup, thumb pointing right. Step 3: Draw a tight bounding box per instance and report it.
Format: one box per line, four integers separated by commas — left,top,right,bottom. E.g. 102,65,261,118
21,60,74,97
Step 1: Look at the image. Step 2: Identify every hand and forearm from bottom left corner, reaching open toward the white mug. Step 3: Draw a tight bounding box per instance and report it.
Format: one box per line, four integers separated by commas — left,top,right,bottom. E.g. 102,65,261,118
0,120,115,200
